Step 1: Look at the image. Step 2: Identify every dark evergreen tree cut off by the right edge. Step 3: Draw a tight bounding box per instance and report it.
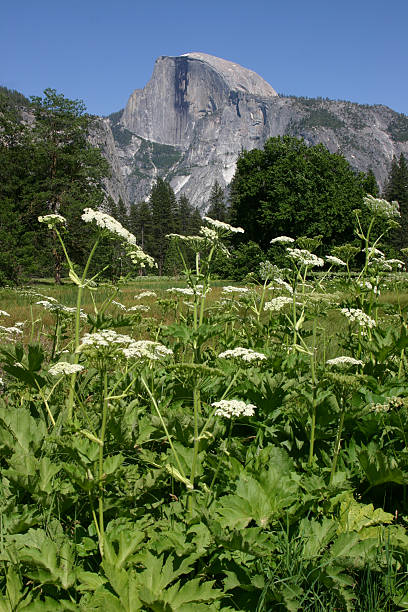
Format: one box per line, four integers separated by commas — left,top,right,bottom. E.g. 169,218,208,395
384,153,408,249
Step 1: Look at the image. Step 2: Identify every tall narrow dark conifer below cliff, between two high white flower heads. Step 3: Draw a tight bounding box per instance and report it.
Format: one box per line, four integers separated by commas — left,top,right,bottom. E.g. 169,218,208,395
149,178,177,276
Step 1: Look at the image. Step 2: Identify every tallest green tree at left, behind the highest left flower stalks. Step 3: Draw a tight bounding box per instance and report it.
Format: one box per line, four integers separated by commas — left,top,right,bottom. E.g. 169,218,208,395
31,89,109,282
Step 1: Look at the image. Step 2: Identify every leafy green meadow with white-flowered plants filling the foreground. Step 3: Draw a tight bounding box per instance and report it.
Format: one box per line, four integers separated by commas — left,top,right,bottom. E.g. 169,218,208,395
0,198,408,612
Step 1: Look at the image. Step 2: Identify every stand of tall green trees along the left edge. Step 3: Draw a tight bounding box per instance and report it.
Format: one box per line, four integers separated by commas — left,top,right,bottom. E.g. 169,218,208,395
0,89,109,282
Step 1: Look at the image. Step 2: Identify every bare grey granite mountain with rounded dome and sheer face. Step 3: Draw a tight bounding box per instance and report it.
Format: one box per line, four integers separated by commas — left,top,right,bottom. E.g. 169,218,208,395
98,53,408,209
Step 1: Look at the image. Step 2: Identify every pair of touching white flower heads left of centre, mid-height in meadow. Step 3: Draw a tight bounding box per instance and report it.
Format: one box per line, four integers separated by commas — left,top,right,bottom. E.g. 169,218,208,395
77,329,173,360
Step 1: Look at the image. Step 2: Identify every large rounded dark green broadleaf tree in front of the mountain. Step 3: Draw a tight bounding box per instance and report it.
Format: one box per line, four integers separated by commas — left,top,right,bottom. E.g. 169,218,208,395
231,136,365,248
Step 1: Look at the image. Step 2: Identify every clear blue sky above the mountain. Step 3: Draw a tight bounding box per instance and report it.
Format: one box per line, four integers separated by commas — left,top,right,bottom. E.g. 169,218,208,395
0,0,408,115
